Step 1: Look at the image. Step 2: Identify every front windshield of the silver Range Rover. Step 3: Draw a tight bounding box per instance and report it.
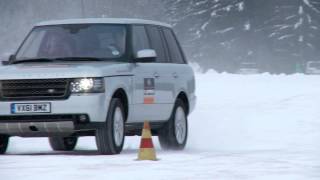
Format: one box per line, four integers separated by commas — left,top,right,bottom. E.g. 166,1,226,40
16,24,127,61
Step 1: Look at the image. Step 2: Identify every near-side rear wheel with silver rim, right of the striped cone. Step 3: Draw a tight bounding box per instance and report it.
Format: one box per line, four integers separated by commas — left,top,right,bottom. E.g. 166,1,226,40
159,99,188,150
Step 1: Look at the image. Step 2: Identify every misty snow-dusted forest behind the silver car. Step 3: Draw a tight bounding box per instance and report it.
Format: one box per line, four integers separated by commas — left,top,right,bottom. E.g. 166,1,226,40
0,0,320,74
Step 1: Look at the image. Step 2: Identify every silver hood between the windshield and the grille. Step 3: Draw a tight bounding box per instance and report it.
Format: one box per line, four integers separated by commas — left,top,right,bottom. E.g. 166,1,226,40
0,62,131,80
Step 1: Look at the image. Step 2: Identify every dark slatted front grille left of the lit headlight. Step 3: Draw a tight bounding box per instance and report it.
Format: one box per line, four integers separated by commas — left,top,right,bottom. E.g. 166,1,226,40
0,79,70,100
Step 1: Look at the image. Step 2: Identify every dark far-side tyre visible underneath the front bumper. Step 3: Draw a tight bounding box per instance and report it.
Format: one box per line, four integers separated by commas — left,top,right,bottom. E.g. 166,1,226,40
49,136,78,151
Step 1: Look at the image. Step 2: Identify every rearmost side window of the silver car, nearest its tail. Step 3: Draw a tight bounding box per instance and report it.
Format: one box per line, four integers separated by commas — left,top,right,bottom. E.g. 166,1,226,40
163,28,185,64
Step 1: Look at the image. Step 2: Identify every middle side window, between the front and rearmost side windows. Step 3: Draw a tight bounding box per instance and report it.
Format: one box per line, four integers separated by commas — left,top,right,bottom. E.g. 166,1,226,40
147,26,168,62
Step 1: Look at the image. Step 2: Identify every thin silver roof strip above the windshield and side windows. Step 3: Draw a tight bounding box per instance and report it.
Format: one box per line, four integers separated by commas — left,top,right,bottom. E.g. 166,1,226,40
36,18,172,28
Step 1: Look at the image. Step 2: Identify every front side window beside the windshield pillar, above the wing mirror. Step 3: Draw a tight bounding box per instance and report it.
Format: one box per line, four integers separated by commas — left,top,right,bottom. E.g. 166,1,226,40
132,26,150,53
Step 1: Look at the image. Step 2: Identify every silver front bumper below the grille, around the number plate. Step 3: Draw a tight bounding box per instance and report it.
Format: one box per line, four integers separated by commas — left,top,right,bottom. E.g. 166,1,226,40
0,93,109,136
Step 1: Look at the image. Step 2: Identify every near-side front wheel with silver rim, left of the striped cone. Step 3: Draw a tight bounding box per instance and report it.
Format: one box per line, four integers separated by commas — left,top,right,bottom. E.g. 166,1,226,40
96,98,125,155
